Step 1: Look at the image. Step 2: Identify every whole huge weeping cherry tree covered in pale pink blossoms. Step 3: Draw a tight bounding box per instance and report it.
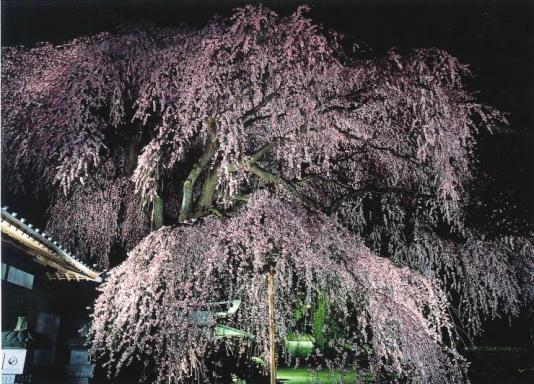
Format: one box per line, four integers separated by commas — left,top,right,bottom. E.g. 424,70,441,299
2,6,534,383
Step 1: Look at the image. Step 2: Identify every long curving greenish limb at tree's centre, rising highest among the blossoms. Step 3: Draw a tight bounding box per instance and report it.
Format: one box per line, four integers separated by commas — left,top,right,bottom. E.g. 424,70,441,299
179,118,219,222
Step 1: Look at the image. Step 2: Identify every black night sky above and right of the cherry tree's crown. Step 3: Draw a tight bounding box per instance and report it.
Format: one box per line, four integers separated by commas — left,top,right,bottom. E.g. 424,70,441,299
1,0,534,228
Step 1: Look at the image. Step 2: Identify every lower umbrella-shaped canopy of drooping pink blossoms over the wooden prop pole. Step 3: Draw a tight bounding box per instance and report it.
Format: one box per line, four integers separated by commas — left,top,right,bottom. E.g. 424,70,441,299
90,192,464,383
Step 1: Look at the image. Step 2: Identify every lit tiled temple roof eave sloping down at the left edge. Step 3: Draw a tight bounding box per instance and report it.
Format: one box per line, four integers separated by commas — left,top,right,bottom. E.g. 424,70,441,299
1,207,102,282
